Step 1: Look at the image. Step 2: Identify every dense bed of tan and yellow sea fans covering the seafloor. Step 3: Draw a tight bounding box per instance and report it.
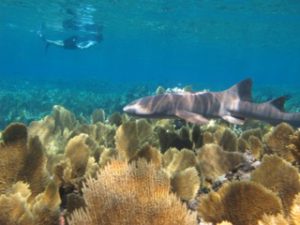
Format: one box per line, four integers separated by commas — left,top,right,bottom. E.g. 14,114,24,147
0,103,300,225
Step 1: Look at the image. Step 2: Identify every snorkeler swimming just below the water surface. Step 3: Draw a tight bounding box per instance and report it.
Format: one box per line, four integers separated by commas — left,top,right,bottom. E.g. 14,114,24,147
38,31,103,50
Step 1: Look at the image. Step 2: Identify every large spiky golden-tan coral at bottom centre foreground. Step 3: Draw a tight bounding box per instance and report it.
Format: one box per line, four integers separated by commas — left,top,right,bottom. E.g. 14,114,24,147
68,160,197,225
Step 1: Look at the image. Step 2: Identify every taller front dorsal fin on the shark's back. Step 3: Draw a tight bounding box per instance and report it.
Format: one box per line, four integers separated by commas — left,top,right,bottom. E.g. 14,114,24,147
227,78,252,102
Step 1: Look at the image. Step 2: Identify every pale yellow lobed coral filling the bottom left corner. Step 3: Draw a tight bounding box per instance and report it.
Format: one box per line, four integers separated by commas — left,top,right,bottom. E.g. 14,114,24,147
0,182,60,225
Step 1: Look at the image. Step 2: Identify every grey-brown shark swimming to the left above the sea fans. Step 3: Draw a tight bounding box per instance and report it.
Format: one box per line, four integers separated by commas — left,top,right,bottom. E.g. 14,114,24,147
123,79,300,127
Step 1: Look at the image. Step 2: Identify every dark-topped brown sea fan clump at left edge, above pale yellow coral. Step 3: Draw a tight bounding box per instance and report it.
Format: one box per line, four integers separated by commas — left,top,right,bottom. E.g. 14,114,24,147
0,124,48,196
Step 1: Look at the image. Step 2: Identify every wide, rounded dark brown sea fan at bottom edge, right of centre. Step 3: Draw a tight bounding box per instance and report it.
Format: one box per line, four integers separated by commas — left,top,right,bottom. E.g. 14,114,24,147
198,181,282,225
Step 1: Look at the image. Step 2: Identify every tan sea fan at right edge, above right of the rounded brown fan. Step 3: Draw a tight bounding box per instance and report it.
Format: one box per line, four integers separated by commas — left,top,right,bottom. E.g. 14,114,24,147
251,155,300,214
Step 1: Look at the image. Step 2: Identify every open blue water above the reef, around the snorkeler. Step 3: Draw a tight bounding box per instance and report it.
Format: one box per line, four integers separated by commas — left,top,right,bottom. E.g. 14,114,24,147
0,0,300,128
